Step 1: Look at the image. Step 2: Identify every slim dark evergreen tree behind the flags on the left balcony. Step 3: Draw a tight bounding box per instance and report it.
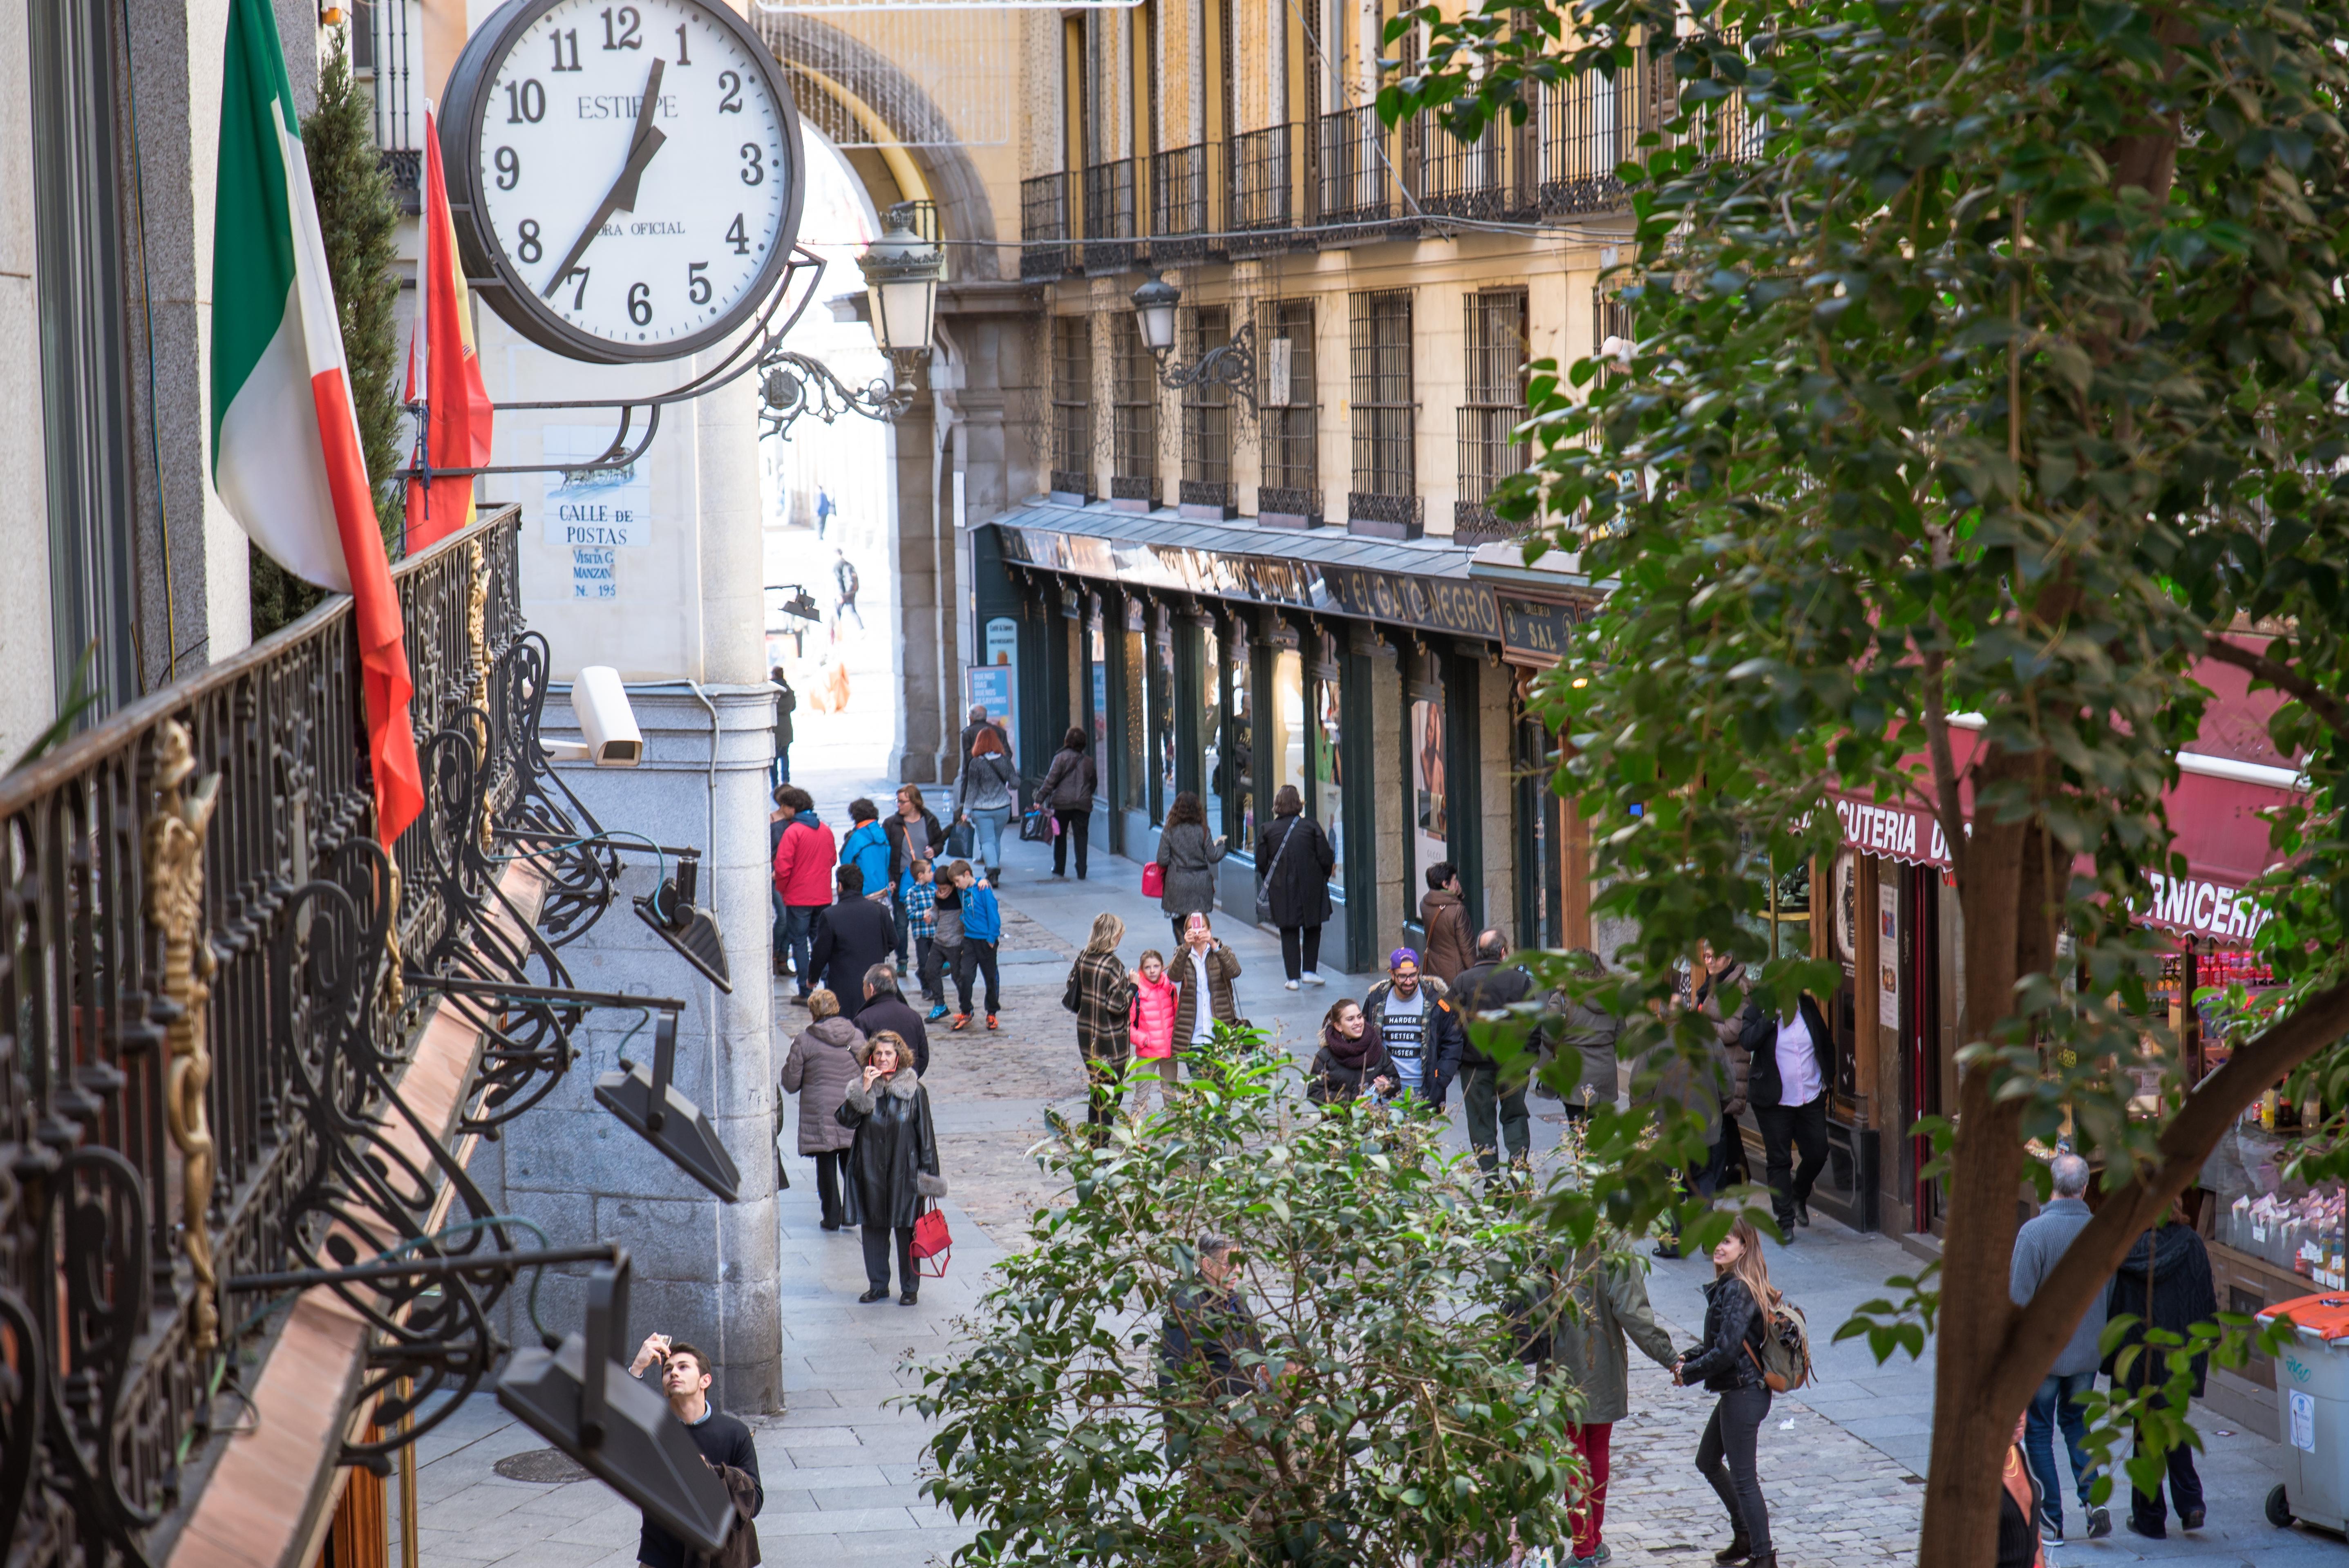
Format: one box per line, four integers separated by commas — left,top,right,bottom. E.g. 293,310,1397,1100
251,33,406,636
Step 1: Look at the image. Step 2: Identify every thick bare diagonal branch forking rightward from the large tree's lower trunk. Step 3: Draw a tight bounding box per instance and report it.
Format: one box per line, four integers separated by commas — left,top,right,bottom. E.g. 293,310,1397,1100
1992,981,2349,1411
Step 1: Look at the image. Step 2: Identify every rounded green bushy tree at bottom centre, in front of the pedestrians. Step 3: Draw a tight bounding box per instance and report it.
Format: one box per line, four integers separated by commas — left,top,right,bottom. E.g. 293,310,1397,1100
911,1033,1606,1568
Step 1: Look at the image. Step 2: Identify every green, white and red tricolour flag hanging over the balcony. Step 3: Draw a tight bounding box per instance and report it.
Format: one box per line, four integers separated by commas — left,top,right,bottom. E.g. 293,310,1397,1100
211,0,423,850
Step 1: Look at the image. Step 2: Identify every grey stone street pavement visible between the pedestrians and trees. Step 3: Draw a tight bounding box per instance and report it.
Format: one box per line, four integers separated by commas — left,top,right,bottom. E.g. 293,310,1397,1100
404,751,2349,1568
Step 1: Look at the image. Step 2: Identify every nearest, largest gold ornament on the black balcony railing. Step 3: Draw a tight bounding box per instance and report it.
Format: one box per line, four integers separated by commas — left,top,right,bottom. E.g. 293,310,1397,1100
141,718,221,1354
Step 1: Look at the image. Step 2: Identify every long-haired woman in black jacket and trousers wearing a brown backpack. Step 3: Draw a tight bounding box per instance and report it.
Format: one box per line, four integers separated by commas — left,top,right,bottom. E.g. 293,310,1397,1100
1673,1214,1778,1568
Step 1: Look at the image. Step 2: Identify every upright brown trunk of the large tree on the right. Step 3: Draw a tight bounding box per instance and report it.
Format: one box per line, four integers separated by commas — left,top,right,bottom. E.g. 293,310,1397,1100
1917,754,2069,1568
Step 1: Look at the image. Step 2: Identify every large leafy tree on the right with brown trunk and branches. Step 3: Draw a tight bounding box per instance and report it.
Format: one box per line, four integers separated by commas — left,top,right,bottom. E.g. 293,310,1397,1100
1381,0,2349,1568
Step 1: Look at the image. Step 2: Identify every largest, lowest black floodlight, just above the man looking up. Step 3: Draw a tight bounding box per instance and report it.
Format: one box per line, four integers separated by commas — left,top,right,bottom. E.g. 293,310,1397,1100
498,1249,735,1554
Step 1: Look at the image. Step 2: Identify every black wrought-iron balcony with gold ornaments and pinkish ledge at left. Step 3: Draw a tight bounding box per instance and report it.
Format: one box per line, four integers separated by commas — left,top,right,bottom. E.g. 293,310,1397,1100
0,507,747,1568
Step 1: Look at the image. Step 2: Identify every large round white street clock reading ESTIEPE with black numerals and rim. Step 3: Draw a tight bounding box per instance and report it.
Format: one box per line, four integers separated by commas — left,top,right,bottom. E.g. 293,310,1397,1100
439,0,801,364
